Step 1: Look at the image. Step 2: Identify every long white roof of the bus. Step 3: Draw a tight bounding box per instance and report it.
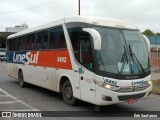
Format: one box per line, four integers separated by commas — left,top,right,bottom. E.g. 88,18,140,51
8,16,138,39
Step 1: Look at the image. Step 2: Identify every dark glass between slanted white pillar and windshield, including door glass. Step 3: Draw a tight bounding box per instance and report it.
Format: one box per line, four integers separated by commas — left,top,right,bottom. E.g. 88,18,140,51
68,27,93,70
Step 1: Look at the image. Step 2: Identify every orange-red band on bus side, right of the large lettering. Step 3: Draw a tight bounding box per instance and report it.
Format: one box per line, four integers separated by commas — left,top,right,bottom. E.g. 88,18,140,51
29,50,72,70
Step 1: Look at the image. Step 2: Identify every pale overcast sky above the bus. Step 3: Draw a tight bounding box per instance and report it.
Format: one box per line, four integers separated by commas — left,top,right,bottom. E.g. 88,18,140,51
0,0,160,32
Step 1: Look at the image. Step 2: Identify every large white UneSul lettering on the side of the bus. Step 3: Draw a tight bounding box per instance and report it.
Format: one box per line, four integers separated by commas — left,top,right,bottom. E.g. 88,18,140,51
13,52,39,64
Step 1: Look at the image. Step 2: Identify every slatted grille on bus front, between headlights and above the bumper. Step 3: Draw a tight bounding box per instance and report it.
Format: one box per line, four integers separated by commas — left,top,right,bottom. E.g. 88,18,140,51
117,85,149,93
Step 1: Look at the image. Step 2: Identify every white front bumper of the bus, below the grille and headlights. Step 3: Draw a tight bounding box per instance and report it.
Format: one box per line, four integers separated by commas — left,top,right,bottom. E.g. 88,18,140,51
96,86,152,106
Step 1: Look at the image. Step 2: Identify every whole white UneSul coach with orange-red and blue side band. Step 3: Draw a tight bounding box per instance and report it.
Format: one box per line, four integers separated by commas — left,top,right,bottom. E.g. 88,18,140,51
7,17,152,106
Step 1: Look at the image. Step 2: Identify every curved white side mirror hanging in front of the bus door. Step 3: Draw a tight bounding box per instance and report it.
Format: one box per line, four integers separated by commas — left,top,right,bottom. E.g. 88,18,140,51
82,28,102,50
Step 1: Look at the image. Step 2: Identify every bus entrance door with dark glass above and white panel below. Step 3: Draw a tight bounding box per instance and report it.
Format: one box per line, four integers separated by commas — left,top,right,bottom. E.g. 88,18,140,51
76,37,96,102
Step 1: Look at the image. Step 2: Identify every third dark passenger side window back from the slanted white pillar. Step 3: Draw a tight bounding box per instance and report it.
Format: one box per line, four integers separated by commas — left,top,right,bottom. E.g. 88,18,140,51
26,34,35,50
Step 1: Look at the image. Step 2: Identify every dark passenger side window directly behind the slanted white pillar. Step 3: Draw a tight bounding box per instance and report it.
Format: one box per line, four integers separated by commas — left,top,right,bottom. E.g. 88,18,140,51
49,26,67,49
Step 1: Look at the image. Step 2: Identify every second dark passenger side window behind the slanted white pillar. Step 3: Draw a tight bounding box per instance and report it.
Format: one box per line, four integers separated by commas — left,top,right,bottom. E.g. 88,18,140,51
36,30,49,49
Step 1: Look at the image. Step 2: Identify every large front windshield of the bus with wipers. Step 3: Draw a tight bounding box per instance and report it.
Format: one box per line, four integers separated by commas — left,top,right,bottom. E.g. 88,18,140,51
92,26,150,75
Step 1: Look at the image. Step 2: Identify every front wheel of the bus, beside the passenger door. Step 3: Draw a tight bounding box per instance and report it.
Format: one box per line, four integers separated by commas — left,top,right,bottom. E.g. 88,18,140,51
62,80,76,106
